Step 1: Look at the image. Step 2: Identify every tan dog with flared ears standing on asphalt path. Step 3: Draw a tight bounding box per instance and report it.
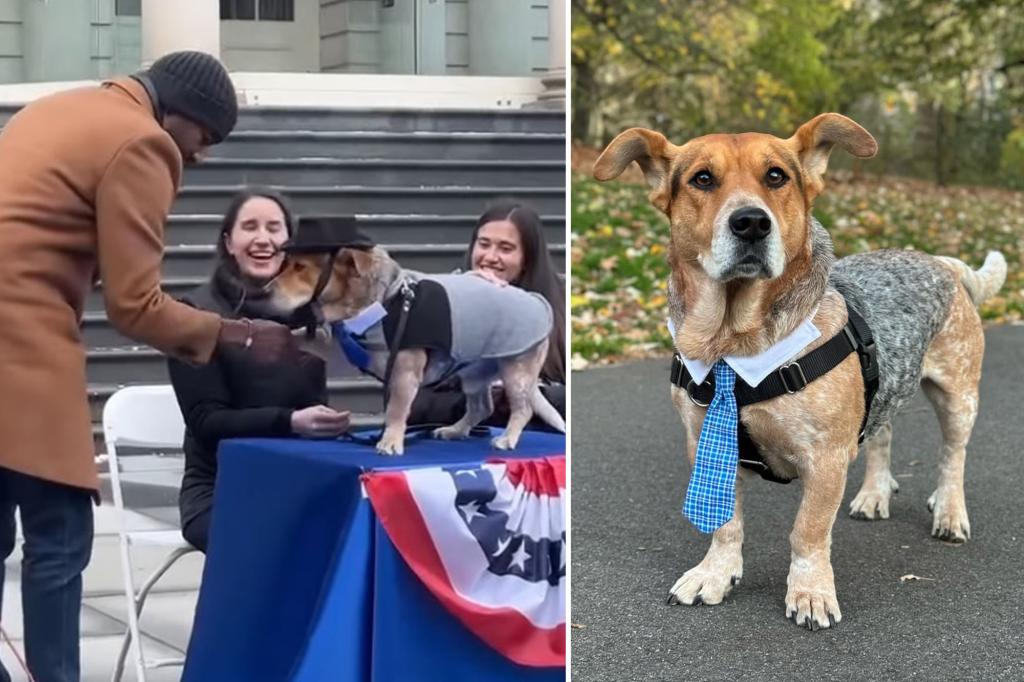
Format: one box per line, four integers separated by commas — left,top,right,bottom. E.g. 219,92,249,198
594,114,1006,629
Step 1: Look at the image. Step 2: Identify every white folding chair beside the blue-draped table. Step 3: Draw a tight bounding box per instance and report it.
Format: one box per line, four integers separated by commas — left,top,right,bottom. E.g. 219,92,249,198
103,386,197,682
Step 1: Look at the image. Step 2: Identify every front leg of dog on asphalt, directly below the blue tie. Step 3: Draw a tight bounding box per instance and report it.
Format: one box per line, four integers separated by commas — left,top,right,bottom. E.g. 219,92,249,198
669,466,749,606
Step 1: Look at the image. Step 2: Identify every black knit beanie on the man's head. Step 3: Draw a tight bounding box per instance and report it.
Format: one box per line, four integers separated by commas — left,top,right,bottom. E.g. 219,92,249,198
147,51,239,144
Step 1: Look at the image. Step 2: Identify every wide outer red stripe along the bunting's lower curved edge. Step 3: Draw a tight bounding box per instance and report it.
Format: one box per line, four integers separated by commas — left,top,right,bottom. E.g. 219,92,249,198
362,471,565,668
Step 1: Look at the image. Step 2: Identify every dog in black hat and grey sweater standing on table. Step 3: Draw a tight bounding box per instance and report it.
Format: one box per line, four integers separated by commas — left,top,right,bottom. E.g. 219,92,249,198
270,217,565,455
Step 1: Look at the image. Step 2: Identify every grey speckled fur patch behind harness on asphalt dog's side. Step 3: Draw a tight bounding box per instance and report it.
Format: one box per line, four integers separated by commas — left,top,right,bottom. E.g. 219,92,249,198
829,250,958,436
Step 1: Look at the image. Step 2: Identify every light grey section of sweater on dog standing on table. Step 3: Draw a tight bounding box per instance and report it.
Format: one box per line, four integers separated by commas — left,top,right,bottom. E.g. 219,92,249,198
424,274,554,363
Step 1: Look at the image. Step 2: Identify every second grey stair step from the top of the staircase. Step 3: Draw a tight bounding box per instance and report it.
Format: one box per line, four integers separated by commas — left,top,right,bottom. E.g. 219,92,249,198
212,130,565,163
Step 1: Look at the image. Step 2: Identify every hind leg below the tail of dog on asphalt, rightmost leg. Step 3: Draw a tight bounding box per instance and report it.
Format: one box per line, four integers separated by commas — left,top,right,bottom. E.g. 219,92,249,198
922,284,985,543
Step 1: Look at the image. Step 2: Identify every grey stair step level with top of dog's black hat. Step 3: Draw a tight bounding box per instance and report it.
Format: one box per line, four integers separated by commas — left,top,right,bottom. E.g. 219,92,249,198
164,212,565,247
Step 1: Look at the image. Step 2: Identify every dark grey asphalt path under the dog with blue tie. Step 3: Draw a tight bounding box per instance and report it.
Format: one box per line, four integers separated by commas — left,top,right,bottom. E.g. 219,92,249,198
570,327,1024,682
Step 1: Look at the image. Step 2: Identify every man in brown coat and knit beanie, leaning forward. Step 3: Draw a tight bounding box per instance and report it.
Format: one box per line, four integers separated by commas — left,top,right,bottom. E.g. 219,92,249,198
0,52,294,682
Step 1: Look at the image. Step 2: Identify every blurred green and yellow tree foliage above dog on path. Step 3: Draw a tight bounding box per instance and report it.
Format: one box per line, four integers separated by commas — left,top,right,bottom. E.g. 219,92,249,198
572,0,1024,184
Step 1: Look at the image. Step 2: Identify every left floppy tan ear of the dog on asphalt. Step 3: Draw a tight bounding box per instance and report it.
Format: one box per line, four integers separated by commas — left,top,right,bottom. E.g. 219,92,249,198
594,128,675,211
